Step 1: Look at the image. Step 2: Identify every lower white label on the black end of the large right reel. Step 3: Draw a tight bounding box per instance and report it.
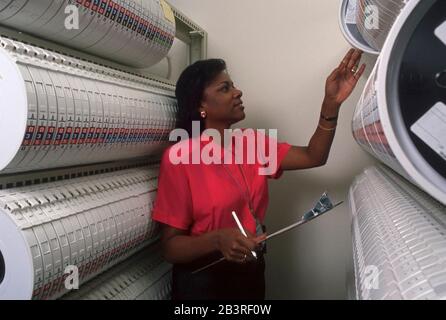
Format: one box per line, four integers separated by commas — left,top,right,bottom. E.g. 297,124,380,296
410,102,446,160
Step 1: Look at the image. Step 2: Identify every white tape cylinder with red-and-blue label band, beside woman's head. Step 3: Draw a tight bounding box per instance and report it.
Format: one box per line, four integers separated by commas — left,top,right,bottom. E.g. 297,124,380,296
0,38,177,173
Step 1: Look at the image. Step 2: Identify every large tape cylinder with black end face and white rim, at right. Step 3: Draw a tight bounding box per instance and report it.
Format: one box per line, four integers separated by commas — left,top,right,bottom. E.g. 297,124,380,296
352,0,446,204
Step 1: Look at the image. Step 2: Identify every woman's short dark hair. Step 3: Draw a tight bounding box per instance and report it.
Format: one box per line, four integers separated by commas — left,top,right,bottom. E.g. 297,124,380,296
175,59,226,136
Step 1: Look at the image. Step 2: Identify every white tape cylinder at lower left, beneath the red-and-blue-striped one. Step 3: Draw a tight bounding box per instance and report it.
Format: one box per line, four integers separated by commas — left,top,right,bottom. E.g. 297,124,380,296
0,167,158,299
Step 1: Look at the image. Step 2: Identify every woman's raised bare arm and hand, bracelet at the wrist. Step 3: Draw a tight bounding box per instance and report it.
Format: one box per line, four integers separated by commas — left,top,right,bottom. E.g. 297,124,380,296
281,49,365,170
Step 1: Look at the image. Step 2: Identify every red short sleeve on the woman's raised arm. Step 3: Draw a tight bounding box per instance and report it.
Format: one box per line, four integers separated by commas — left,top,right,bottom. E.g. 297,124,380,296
256,130,291,179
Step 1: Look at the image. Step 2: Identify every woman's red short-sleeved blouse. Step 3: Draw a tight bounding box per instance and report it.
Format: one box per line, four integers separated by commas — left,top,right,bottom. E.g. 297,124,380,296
152,129,291,235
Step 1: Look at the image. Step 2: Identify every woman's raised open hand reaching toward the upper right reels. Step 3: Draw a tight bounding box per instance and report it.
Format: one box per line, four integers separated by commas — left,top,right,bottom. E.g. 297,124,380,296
325,49,365,105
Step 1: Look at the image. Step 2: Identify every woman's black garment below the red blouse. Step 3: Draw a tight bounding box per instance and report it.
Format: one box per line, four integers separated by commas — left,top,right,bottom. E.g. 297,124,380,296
172,254,265,300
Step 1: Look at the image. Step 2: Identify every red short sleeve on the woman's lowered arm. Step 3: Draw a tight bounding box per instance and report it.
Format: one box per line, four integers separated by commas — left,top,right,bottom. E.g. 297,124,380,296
152,148,192,230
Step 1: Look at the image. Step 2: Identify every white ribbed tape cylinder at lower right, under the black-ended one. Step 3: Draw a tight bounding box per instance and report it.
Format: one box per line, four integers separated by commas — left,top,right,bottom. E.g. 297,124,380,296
349,167,446,300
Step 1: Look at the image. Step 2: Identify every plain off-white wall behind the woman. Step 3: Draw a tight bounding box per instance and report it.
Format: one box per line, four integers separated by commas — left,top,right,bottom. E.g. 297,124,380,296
170,0,373,299
